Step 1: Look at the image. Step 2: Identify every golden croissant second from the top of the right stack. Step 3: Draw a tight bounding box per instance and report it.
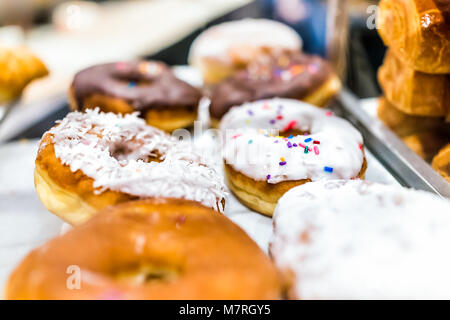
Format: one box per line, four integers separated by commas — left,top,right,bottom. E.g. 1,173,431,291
378,49,450,117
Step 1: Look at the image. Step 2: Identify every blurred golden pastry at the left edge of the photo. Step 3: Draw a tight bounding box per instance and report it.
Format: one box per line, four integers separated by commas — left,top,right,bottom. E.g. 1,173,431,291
0,47,48,103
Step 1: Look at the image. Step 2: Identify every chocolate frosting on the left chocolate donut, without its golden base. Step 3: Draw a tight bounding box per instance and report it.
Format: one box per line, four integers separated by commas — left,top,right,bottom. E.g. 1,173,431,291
72,61,201,112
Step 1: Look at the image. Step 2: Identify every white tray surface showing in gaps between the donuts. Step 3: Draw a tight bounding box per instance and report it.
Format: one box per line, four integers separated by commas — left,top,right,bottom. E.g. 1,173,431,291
0,131,397,296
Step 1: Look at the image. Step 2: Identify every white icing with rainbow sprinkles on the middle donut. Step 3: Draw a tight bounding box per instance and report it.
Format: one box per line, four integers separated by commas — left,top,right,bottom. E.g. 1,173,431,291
220,98,364,183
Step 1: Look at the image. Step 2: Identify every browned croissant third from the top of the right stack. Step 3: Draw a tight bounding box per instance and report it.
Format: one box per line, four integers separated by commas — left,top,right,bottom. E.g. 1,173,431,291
377,98,450,137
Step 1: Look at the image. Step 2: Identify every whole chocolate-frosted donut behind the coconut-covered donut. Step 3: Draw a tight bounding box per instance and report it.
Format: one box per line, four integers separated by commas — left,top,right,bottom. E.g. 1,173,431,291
69,61,201,131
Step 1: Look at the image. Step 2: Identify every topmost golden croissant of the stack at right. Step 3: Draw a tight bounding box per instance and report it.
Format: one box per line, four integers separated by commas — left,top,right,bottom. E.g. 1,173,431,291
377,0,450,74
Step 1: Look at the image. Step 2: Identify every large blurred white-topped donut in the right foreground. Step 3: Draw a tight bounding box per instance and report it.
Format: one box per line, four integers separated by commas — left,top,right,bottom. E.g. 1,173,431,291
269,180,450,300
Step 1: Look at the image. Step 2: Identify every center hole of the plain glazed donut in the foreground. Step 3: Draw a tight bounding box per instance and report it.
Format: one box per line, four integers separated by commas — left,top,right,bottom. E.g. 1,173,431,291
111,262,181,285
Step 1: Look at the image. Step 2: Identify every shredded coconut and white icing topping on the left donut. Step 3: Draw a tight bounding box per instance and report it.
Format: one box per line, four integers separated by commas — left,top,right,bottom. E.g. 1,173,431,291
46,109,225,210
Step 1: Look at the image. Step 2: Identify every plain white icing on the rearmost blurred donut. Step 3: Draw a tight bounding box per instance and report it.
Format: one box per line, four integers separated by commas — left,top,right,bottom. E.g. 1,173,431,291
188,19,302,63
